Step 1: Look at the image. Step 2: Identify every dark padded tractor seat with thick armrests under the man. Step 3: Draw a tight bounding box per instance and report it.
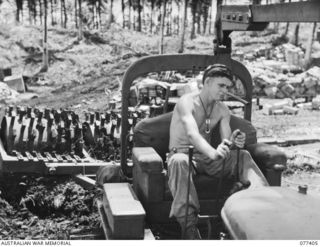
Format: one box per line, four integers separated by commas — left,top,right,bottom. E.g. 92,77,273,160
132,112,286,220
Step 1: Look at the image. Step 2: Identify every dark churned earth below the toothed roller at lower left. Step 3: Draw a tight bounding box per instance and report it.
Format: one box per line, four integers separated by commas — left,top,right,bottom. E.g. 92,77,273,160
0,176,100,240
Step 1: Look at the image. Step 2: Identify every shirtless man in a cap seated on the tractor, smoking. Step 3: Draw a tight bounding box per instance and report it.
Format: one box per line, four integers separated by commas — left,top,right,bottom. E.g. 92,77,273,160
168,64,268,239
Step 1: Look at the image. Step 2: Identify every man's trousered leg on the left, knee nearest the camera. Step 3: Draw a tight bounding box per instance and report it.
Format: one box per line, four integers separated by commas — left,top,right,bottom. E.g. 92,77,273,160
168,153,200,239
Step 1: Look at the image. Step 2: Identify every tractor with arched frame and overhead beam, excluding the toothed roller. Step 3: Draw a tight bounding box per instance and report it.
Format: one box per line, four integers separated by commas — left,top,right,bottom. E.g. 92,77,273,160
100,1,320,240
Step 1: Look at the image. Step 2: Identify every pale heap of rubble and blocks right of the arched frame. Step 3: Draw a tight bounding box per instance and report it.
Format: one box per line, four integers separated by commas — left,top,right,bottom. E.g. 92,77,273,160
238,43,320,99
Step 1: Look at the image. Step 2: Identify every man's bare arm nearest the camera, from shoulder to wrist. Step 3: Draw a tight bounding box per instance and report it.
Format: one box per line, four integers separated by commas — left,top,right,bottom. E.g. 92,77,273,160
177,97,219,160
